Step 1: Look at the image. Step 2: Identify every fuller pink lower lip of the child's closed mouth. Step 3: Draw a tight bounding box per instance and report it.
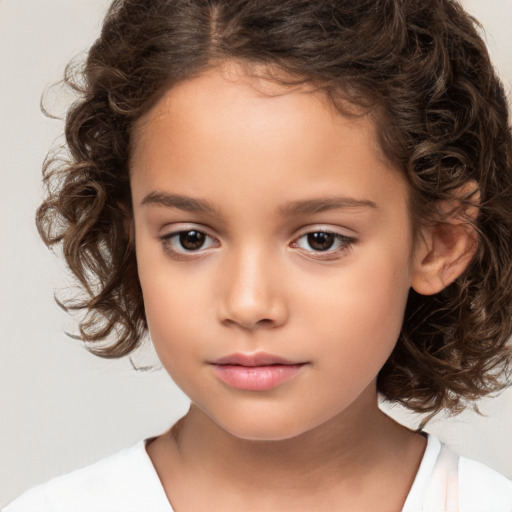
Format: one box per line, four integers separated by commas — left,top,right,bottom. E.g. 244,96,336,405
213,364,304,391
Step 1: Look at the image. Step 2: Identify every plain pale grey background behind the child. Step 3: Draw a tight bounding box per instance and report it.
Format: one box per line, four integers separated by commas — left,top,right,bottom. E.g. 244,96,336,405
0,0,512,506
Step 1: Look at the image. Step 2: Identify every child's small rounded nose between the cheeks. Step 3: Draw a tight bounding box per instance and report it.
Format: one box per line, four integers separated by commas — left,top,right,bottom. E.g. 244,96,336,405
218,248,288,330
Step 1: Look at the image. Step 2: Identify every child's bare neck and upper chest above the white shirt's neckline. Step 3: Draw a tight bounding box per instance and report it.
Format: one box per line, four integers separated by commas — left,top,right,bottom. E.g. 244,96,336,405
147,390,425,512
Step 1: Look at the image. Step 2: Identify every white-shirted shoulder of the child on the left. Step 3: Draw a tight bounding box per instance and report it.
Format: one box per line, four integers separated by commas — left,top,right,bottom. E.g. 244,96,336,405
2,441,171,512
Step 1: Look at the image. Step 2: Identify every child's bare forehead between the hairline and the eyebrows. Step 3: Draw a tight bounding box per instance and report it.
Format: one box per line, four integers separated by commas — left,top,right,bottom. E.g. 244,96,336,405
131,62,408,218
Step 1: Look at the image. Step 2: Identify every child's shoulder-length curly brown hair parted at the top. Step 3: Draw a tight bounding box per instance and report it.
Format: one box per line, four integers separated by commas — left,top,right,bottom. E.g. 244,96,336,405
37,0,512,413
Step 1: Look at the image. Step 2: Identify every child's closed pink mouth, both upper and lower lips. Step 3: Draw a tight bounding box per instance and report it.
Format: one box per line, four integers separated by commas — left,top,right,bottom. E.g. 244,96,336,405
211,353,305,391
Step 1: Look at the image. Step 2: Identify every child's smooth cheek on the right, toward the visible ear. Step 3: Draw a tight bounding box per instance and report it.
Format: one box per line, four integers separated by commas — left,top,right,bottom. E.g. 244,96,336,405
303,246,410,374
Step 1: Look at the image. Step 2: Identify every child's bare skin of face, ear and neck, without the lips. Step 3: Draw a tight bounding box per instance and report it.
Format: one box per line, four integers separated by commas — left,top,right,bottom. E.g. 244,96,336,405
131,65,476,512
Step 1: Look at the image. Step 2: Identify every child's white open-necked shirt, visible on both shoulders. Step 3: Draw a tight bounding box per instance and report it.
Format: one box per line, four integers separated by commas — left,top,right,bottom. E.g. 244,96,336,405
3,435,512,512
